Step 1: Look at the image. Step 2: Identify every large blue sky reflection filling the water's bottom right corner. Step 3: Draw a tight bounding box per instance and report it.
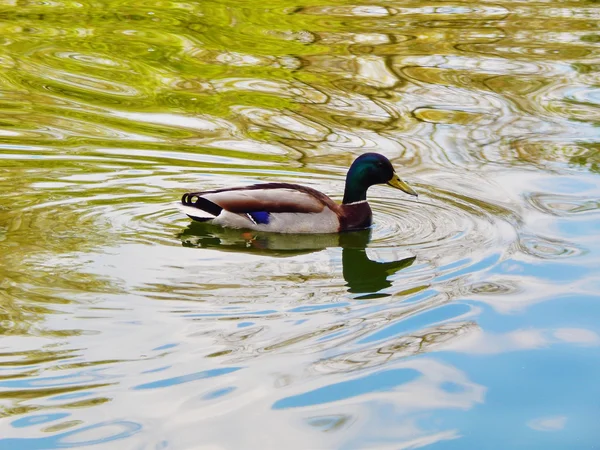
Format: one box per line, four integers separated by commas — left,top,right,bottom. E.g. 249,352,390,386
428,345,600,450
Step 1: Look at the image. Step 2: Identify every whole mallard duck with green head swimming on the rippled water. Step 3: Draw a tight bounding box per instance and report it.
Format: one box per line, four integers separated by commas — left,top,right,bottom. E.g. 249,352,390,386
181,153,417,233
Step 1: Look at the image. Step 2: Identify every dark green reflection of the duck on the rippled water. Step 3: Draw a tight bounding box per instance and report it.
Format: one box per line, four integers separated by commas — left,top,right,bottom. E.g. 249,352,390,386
179,222,416,298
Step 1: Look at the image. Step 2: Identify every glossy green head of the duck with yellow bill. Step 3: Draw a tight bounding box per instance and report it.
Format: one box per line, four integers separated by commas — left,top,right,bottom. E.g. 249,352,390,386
343,153,417,203
